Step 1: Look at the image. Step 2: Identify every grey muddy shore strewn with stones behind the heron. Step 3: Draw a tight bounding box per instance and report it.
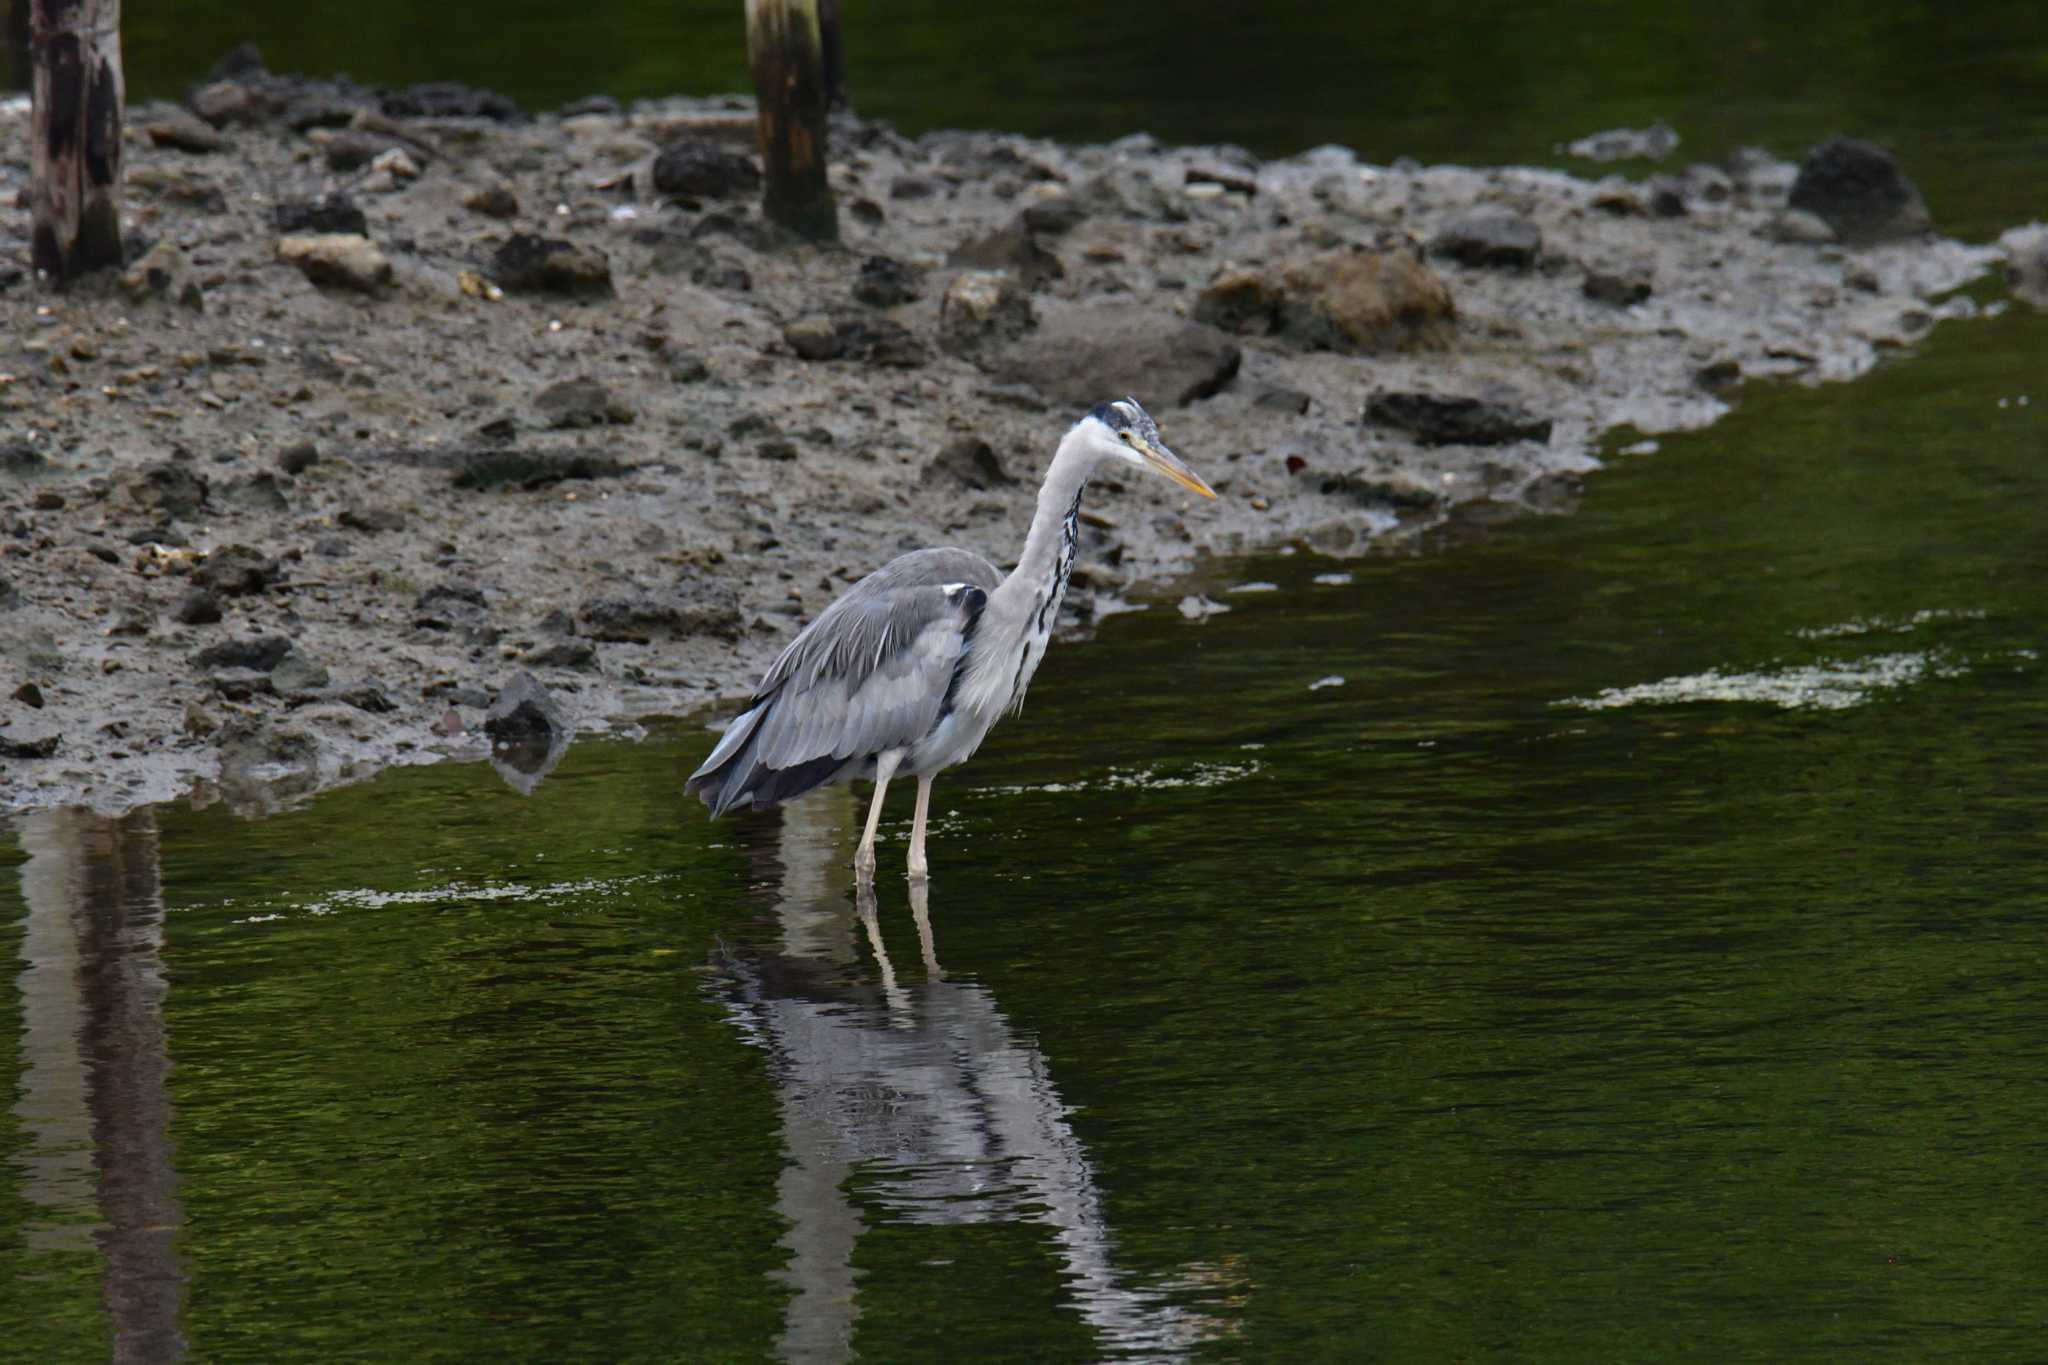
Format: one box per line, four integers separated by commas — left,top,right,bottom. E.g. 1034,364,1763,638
0,55,1999,810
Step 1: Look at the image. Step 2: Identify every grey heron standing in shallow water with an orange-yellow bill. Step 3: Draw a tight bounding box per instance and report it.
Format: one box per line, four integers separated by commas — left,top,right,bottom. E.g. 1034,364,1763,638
684,397,1217,878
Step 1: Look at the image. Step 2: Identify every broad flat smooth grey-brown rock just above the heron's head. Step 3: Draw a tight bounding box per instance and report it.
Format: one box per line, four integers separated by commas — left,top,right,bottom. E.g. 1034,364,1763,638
979,303,1243,407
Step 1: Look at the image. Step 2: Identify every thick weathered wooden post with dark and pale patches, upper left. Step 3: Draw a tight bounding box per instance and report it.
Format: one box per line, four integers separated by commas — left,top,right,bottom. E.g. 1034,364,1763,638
29,0,123,284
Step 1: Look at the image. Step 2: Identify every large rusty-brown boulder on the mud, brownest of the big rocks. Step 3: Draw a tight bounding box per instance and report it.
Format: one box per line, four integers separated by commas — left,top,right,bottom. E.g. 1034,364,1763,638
1194,233,1456,354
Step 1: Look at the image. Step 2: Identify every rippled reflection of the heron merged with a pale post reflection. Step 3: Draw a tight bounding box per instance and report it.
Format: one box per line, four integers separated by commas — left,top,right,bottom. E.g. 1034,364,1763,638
721,798,1221,1361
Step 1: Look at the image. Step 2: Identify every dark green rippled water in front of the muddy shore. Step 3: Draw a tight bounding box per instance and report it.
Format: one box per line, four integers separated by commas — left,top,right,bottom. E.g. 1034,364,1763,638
0,298,2048,1361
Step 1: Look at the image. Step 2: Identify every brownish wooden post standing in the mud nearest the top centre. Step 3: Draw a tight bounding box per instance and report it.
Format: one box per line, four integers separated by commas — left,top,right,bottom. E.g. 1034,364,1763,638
748,0,840,241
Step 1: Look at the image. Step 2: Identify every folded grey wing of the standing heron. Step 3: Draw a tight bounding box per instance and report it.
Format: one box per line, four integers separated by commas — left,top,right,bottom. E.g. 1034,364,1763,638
754,583,981,767
